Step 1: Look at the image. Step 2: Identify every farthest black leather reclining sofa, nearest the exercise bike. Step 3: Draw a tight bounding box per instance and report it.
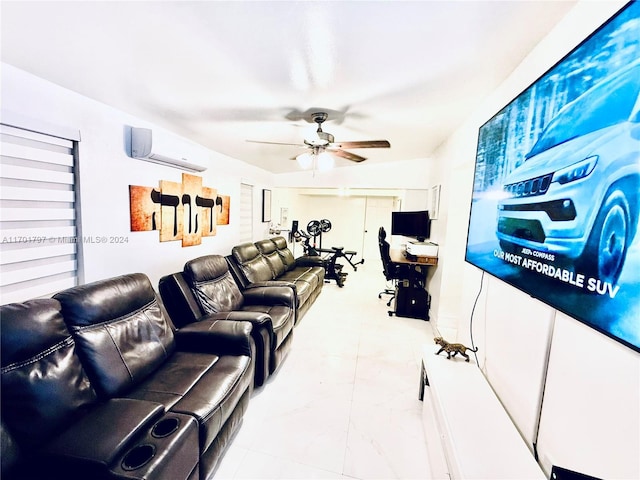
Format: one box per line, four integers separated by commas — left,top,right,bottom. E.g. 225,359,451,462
227,236,325,324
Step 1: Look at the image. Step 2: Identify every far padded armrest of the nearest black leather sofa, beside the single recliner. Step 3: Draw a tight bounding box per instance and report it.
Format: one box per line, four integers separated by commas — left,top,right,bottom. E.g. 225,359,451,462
176,314,253,357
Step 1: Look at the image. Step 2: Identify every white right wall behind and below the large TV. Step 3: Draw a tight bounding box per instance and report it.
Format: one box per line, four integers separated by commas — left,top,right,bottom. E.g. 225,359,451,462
432,1,640,478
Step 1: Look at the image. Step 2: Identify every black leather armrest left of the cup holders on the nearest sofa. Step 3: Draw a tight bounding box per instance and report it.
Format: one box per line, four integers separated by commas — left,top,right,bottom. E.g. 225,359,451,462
42,398,164,478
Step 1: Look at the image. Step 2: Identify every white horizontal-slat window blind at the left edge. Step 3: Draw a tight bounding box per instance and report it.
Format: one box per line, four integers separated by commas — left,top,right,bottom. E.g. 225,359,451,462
0,124,81,304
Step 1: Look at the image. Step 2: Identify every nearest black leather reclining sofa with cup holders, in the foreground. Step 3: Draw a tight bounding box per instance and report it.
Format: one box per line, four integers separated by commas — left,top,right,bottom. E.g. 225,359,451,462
0,274,255,480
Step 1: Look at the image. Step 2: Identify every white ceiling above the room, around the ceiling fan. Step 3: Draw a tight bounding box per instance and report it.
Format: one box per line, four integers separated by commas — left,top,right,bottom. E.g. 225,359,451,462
0,0,575,173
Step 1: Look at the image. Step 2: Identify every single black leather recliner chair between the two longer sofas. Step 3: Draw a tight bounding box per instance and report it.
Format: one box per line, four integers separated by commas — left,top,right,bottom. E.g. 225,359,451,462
158,255,296,386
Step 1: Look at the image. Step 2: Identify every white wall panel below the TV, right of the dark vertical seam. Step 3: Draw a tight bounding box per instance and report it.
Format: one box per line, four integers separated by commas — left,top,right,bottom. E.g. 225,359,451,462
538,313,640,479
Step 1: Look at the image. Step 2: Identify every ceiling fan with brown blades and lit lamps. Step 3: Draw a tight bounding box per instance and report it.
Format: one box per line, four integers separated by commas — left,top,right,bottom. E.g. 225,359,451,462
247,112,391,163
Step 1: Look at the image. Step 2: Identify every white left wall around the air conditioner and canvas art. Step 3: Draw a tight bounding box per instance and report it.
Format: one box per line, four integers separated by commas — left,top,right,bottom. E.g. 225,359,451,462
1,64,273,285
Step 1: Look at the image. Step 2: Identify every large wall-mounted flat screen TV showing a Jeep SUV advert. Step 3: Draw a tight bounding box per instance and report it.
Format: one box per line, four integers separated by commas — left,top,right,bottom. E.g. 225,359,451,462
465,2,640,351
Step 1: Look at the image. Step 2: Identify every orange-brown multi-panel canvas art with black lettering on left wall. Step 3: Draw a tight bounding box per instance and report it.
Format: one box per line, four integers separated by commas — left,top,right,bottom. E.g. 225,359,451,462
129,173,231,247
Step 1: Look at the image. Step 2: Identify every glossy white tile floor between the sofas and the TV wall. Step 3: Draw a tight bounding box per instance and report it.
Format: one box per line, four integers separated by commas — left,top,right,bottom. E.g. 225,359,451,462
215,261,432,479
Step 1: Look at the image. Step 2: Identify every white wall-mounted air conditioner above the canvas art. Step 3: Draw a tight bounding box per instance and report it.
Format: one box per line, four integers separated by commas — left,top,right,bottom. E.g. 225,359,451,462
130,127,207,172
